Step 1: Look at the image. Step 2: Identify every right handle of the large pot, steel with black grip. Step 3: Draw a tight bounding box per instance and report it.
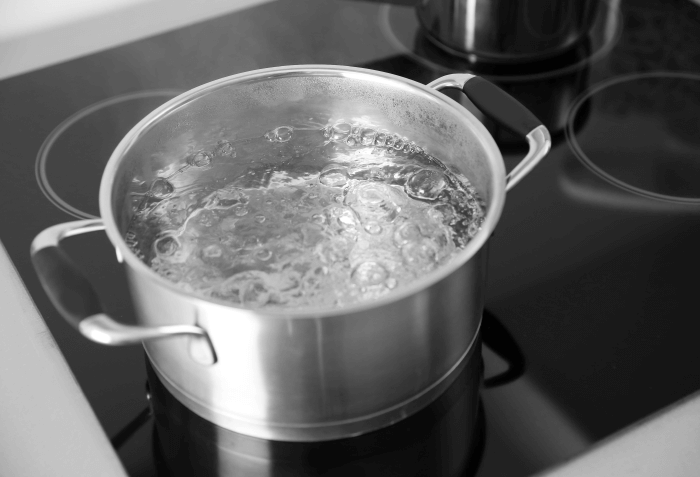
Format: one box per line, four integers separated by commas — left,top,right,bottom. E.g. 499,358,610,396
428,73,552,191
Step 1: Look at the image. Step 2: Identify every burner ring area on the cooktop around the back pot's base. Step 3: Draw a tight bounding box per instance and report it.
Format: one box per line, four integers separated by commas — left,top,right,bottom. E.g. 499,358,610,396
379,0,622,81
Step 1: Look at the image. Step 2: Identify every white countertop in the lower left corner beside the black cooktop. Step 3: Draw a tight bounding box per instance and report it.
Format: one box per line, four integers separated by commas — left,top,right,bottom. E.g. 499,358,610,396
0,243,126,477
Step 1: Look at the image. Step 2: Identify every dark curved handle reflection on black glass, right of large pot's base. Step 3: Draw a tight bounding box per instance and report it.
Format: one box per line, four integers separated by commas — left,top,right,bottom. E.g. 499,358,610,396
481,310,525,388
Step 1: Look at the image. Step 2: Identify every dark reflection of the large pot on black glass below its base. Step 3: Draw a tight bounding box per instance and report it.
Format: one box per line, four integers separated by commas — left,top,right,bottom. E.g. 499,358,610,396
148,354,484,477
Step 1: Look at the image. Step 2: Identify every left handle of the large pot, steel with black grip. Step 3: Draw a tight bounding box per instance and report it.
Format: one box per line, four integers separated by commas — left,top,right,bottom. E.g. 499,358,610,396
31,219,216,364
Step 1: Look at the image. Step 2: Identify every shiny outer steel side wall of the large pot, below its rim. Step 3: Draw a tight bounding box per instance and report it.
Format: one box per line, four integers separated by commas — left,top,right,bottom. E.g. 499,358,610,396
134,251,486,441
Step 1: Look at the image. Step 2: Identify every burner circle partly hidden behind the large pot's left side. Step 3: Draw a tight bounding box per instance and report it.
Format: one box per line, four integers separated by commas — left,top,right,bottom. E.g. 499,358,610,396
34,89,181,219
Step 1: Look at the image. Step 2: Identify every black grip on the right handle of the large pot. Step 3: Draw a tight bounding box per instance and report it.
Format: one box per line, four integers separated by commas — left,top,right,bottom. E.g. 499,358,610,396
462,76,542,136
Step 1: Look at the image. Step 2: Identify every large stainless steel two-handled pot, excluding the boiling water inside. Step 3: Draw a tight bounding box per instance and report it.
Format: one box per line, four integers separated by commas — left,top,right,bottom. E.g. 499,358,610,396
31,65,550,441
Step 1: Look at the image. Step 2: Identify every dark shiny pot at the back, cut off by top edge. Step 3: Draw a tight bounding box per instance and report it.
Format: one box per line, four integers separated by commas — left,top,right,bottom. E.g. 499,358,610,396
417,0,602,62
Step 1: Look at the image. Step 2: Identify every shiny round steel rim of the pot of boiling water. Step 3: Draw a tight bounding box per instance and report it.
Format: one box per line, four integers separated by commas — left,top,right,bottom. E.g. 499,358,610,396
99,65,506,318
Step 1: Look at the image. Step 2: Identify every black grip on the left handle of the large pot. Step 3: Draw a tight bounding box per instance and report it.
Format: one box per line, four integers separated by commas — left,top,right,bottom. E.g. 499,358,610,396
32,246,102,328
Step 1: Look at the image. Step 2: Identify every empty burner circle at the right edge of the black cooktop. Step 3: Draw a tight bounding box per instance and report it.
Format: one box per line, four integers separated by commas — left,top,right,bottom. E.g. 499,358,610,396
566,71,700,204
